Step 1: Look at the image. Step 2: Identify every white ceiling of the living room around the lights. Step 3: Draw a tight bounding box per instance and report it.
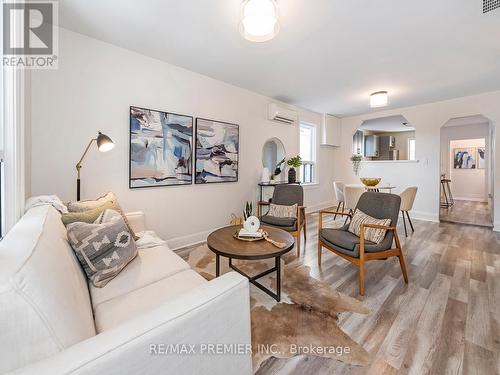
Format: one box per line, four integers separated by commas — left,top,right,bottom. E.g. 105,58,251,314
59,0,500,116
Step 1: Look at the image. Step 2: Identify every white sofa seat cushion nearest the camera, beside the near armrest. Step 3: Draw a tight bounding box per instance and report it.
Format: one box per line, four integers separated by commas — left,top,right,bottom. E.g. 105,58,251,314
94,270,207,332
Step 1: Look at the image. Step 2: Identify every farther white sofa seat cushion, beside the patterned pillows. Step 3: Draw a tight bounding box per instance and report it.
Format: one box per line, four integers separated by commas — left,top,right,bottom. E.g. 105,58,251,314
90,245,190,309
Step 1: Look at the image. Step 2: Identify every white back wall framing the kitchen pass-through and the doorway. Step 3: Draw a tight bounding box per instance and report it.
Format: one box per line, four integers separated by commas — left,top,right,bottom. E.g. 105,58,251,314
334,91,500,231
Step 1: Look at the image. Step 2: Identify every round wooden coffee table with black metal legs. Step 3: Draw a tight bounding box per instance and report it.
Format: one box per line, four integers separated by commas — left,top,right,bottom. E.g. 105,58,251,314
207,225,295,302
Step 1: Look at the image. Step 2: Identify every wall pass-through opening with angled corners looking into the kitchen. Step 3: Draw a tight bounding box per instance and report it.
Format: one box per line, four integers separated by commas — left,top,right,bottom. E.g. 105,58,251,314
352,115,415,161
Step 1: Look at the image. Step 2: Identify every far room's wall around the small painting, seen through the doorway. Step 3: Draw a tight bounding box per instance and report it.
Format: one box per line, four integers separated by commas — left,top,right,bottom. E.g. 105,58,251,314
448,138,487,202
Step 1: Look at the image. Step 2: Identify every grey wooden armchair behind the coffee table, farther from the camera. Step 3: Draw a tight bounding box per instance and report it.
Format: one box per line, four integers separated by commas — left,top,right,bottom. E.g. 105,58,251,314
257,185,307,257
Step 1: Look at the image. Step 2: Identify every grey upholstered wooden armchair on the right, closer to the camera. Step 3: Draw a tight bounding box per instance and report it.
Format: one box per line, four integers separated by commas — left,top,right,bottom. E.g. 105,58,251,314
318,192,408,296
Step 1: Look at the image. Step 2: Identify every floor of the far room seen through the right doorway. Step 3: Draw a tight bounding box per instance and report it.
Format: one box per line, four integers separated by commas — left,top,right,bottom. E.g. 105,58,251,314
439,200,493,228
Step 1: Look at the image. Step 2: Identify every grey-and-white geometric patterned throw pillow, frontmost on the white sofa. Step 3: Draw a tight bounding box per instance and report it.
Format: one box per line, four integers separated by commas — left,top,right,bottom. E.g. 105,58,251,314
67,210,137,288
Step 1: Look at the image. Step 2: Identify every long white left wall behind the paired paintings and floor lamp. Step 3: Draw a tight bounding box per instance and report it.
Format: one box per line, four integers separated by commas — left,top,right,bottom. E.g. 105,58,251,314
31,29,333,247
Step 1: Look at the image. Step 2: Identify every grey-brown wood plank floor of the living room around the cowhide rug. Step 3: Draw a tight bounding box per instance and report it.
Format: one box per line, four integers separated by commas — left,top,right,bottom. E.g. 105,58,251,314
254,210,500,375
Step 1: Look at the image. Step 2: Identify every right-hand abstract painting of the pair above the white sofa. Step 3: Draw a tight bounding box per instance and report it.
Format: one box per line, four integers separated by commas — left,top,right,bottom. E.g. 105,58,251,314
195,118,239,184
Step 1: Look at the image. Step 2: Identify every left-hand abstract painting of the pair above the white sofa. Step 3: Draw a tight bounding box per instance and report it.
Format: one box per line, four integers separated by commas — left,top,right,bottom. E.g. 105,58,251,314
129,107,193,188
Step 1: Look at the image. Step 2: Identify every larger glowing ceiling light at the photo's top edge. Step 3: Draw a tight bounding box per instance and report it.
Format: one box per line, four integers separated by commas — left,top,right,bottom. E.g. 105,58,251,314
240,0,280,42
